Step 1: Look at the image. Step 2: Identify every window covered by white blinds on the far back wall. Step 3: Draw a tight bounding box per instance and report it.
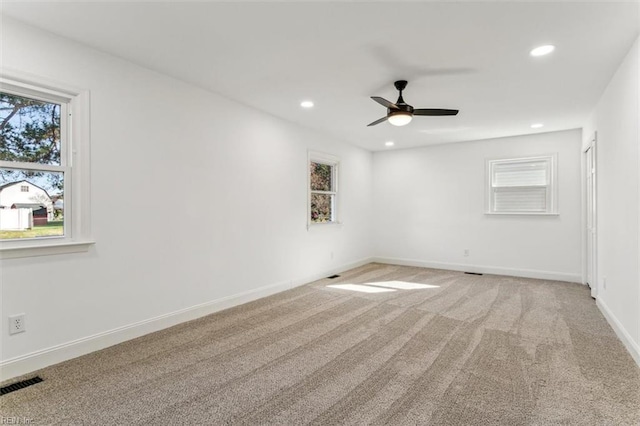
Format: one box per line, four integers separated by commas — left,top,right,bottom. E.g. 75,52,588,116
487,154,557,214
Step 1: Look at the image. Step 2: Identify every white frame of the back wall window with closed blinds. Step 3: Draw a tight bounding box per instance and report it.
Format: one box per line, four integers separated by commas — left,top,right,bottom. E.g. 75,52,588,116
485,153,558,216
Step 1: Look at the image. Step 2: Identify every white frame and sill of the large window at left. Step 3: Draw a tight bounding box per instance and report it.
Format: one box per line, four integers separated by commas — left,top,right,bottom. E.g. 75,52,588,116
0,70,94,259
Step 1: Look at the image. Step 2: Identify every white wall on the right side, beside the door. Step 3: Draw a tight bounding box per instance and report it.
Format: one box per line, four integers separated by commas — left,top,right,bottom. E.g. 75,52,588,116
584,35,640,365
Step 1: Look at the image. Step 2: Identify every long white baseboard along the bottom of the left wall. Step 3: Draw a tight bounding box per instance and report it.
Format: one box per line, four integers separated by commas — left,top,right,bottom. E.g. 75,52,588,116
0,259,371,380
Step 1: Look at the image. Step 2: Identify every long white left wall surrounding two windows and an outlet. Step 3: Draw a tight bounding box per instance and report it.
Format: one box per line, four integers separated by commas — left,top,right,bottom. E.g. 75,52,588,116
0,17,372,377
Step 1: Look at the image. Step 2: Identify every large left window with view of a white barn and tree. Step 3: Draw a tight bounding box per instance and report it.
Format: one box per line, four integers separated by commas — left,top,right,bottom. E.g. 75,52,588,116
0,76,89,258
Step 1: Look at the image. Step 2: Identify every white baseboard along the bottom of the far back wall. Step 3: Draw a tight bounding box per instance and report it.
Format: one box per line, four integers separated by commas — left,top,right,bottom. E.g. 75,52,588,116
371,257,582,283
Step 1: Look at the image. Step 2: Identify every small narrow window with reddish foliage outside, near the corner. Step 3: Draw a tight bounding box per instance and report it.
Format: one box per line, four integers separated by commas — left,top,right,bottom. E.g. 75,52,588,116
308,153,339,225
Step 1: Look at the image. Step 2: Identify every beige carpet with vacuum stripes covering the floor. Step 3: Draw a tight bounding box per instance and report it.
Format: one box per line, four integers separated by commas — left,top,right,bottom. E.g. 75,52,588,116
0,264,640,425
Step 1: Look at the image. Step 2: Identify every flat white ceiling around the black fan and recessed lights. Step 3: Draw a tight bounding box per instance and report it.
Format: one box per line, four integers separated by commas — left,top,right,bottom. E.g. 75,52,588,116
0,0,640,150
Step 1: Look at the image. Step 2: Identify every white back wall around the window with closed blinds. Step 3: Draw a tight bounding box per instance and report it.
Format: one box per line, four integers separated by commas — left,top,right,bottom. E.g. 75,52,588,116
374,130,581,282
